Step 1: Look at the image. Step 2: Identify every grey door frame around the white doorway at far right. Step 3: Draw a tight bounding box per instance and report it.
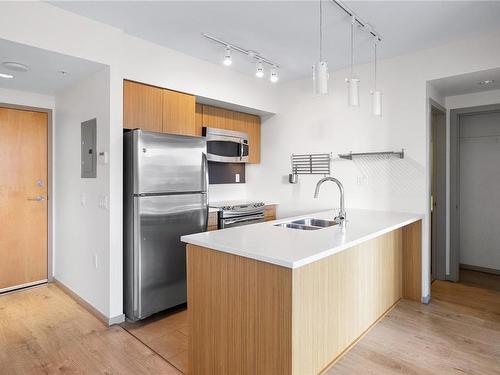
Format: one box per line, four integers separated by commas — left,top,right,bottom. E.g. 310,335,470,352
448,103,500,281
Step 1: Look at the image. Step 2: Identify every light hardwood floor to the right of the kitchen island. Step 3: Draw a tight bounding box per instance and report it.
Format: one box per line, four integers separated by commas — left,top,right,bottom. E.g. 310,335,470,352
327,274,500,375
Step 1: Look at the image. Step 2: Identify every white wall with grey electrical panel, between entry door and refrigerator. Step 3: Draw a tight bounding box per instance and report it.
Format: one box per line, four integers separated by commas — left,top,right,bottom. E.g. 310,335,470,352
54,68,111,316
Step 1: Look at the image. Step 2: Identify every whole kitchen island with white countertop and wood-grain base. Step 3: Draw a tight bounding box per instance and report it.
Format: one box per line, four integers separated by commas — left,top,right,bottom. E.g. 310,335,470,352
182,210,422,375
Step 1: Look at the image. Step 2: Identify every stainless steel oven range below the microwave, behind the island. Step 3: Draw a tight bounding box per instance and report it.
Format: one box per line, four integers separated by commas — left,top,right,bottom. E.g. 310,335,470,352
218,202,264,229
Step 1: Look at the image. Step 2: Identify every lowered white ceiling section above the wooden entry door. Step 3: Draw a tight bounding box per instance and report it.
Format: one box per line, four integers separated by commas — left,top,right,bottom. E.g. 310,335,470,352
0,39,104,95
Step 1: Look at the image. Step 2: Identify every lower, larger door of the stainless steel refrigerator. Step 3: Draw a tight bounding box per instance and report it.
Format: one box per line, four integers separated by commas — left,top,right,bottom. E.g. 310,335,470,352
132,193,208,320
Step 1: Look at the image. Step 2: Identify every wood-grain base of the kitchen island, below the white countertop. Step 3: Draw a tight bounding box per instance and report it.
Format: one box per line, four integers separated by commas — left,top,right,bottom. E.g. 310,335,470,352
187,221,421,375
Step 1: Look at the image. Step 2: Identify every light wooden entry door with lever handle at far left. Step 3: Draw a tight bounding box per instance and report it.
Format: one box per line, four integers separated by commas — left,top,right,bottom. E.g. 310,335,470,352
0,108,48,292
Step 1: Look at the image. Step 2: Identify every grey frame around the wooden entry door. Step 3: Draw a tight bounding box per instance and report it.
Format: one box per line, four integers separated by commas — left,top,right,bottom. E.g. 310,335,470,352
0,102,54,292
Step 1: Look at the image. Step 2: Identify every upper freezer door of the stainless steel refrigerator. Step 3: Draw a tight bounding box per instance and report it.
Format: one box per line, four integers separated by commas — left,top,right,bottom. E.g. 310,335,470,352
133,130,208,194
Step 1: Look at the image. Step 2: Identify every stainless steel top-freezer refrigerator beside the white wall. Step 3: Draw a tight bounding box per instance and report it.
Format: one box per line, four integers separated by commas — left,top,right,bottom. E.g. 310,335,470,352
123,130,208,321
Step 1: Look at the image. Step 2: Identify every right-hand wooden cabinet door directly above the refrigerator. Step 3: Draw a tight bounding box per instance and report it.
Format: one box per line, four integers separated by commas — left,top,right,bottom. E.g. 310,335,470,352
162,89,196,135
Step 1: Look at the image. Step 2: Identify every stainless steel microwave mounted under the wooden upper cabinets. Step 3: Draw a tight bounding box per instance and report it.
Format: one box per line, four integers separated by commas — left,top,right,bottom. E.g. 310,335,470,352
203,127,248,163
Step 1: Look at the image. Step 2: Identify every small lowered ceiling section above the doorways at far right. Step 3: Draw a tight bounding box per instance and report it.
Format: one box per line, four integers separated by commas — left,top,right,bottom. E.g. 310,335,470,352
430,68,500,96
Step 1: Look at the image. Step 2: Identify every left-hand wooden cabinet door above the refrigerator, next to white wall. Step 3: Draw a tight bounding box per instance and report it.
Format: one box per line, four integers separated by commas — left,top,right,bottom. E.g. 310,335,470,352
123,80,162,132
